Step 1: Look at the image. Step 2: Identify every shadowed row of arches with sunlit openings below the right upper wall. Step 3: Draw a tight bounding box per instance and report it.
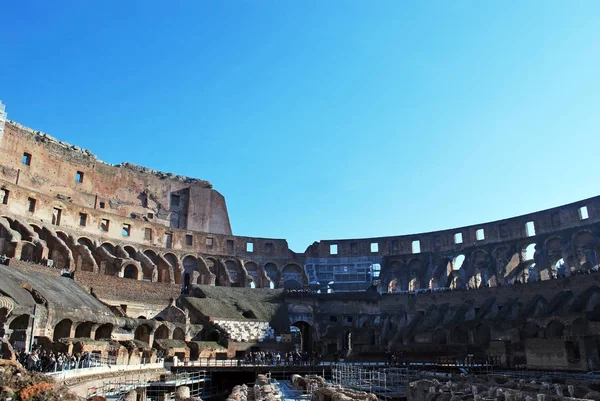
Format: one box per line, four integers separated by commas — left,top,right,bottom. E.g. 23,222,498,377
382,230,600,292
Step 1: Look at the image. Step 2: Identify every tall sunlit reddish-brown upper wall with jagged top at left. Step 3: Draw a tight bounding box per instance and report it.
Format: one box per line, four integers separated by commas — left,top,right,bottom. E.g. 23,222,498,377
0,121,231,235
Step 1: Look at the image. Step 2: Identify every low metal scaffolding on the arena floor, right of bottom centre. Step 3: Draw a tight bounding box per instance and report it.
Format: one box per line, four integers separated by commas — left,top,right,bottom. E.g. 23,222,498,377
331,364,409,400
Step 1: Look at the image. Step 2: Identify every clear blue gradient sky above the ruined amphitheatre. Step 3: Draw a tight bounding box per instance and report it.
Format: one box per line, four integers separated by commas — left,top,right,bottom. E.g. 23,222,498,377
0,0,600,252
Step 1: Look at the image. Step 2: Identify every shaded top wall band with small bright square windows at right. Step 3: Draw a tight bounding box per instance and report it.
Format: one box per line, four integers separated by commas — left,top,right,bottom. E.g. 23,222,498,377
305,196,600,258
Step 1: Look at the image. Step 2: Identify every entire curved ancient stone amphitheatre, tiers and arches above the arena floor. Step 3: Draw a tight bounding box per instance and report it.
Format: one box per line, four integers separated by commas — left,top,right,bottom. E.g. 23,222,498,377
0,101,600,371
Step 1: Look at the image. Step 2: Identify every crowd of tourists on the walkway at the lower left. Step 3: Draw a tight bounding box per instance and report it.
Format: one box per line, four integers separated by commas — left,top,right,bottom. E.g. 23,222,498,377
16,348,95,373
